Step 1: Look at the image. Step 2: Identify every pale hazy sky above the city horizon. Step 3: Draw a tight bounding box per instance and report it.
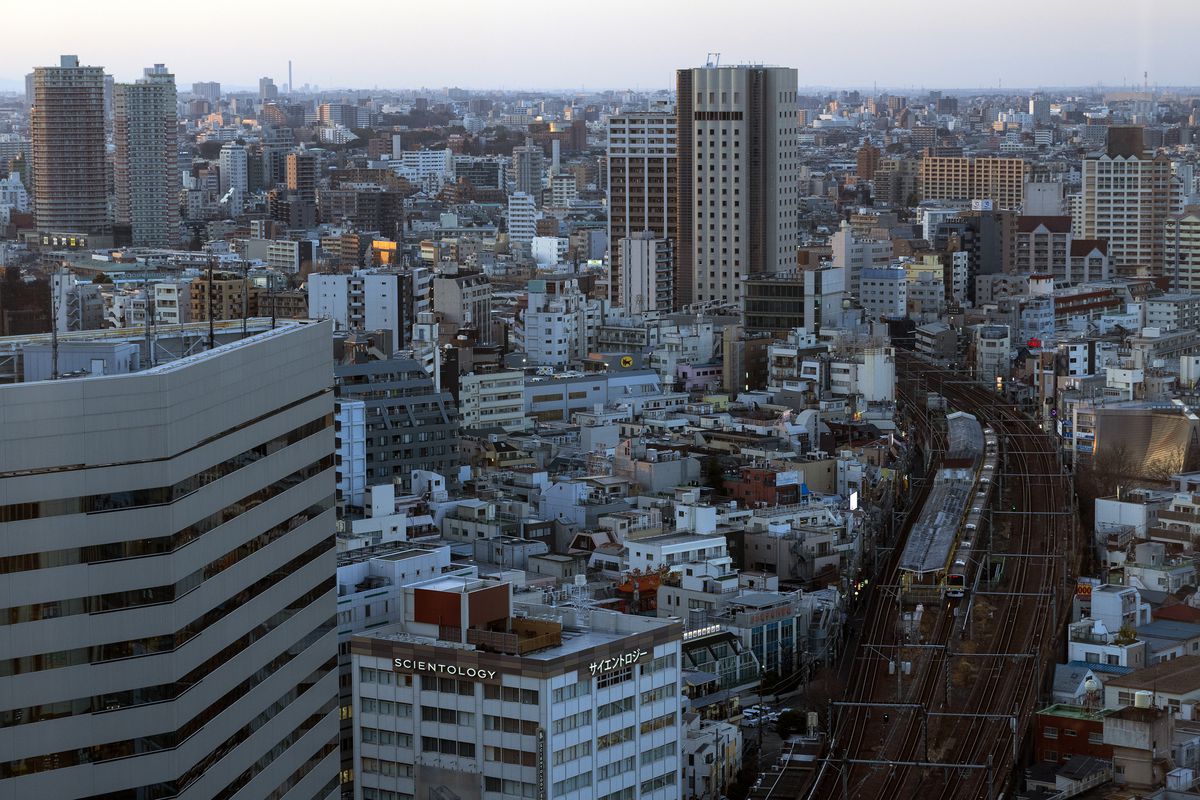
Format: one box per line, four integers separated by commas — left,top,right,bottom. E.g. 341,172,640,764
0,0,1200,91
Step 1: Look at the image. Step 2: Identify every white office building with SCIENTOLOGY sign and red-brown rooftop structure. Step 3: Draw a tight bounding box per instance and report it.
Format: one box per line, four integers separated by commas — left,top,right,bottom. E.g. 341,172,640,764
350,576,683,800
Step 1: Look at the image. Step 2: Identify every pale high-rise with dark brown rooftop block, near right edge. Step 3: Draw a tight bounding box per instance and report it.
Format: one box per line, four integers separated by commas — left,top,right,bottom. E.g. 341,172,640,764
1076,126,1183,275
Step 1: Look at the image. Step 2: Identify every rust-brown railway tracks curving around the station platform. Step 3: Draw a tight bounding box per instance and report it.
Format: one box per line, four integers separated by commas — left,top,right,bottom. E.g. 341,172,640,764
805,351,1075,800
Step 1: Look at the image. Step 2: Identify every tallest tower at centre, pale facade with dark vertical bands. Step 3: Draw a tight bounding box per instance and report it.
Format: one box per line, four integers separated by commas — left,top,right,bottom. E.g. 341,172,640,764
676,66,799,308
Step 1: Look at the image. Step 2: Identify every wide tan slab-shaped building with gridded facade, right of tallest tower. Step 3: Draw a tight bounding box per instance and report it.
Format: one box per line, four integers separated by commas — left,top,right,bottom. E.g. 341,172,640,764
919,156,1030,210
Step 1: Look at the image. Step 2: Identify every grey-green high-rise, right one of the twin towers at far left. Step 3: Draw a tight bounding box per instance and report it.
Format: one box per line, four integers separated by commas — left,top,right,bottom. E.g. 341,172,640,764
113,64,180,247
